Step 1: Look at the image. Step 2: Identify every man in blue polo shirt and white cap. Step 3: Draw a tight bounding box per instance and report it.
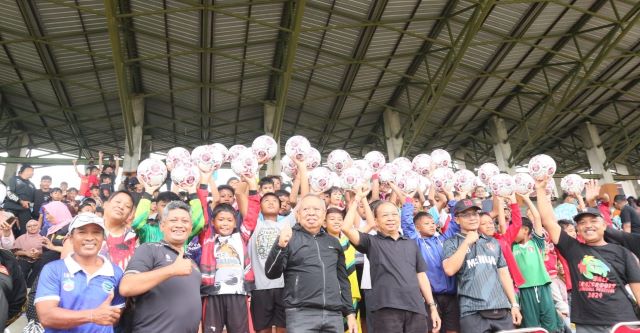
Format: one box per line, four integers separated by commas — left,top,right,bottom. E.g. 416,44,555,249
34,214,124,333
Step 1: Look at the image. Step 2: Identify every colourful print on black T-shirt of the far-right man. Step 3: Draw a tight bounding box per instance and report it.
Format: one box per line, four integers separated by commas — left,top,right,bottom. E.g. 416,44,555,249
578,255,616,299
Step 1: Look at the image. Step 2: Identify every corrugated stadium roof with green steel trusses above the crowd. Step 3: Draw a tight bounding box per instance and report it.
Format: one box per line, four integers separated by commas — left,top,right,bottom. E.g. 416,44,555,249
0,0,640,172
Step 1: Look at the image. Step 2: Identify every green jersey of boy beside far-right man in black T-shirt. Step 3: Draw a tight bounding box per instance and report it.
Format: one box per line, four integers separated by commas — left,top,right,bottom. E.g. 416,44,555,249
511,232,551,288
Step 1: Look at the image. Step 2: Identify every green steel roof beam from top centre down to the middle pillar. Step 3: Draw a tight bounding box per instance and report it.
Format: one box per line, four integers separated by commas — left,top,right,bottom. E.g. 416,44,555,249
271,0,307,142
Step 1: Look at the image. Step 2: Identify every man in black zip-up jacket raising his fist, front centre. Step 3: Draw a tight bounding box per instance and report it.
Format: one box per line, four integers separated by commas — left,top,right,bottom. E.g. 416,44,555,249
265,194,357,333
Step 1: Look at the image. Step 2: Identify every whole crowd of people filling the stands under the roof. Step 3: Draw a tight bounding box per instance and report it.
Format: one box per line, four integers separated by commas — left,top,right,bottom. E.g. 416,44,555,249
0,148,640,333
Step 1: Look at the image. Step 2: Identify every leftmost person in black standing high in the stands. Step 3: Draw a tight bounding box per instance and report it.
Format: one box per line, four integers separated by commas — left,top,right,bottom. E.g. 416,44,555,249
3,164,36,238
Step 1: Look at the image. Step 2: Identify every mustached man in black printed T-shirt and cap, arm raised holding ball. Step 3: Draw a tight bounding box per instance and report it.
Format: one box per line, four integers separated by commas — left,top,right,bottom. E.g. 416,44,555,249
536,177,640,333
